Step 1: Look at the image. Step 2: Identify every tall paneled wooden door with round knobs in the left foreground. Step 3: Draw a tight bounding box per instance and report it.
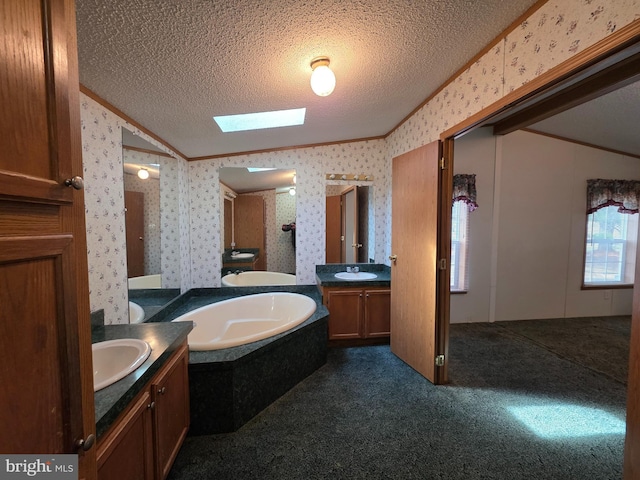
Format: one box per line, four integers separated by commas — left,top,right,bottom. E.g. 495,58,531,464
0,0,96,478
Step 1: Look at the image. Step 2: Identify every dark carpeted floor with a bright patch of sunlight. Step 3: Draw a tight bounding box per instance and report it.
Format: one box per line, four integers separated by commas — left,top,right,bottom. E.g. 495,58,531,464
169,317,630,480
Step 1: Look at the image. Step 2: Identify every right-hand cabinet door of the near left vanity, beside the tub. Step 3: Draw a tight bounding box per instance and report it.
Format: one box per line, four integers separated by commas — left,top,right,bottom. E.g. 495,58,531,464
151,343,189,480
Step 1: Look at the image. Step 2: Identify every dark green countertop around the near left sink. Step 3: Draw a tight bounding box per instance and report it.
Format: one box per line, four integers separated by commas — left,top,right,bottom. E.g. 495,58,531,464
91,322,193,438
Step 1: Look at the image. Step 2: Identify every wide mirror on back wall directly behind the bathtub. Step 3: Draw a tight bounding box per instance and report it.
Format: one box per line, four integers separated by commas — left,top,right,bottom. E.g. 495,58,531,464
219,167,297,274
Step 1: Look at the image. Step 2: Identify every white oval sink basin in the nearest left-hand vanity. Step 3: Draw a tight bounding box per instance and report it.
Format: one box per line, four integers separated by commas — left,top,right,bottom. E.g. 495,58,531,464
91,338,151,392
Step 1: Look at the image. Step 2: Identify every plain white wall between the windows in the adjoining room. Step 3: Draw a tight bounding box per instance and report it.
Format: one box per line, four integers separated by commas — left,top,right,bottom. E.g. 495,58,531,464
451,129,640,323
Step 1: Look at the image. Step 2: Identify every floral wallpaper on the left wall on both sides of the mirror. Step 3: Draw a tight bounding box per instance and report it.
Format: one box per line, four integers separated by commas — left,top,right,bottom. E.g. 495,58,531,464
80,94,190,324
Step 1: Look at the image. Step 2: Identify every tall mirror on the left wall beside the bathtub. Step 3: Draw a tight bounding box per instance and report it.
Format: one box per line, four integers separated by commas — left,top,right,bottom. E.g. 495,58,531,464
122,128,180,296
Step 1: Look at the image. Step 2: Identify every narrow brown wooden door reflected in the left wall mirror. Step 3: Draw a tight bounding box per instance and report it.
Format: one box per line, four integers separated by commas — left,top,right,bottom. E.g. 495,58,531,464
124,190,145,277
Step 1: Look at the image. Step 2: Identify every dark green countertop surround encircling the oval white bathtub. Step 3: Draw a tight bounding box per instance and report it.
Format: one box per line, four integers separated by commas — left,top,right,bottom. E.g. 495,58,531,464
146,285,329,368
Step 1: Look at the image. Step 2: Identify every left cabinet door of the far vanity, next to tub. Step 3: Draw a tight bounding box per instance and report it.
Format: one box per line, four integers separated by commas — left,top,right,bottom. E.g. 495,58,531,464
326,290,363,340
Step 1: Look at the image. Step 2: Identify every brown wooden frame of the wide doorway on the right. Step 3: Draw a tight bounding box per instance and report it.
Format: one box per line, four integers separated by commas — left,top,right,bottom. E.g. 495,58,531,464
437,21,640,479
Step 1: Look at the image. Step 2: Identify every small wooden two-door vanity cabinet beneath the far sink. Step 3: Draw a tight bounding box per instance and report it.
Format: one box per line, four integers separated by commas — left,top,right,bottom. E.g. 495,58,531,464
322,287,391,340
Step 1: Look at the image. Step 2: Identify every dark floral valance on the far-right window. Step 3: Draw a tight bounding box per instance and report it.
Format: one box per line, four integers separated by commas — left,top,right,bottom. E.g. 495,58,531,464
587,178,640,214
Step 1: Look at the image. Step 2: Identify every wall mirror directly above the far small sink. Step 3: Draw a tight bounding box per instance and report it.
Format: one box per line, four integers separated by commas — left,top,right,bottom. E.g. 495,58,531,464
325,182,375,263
